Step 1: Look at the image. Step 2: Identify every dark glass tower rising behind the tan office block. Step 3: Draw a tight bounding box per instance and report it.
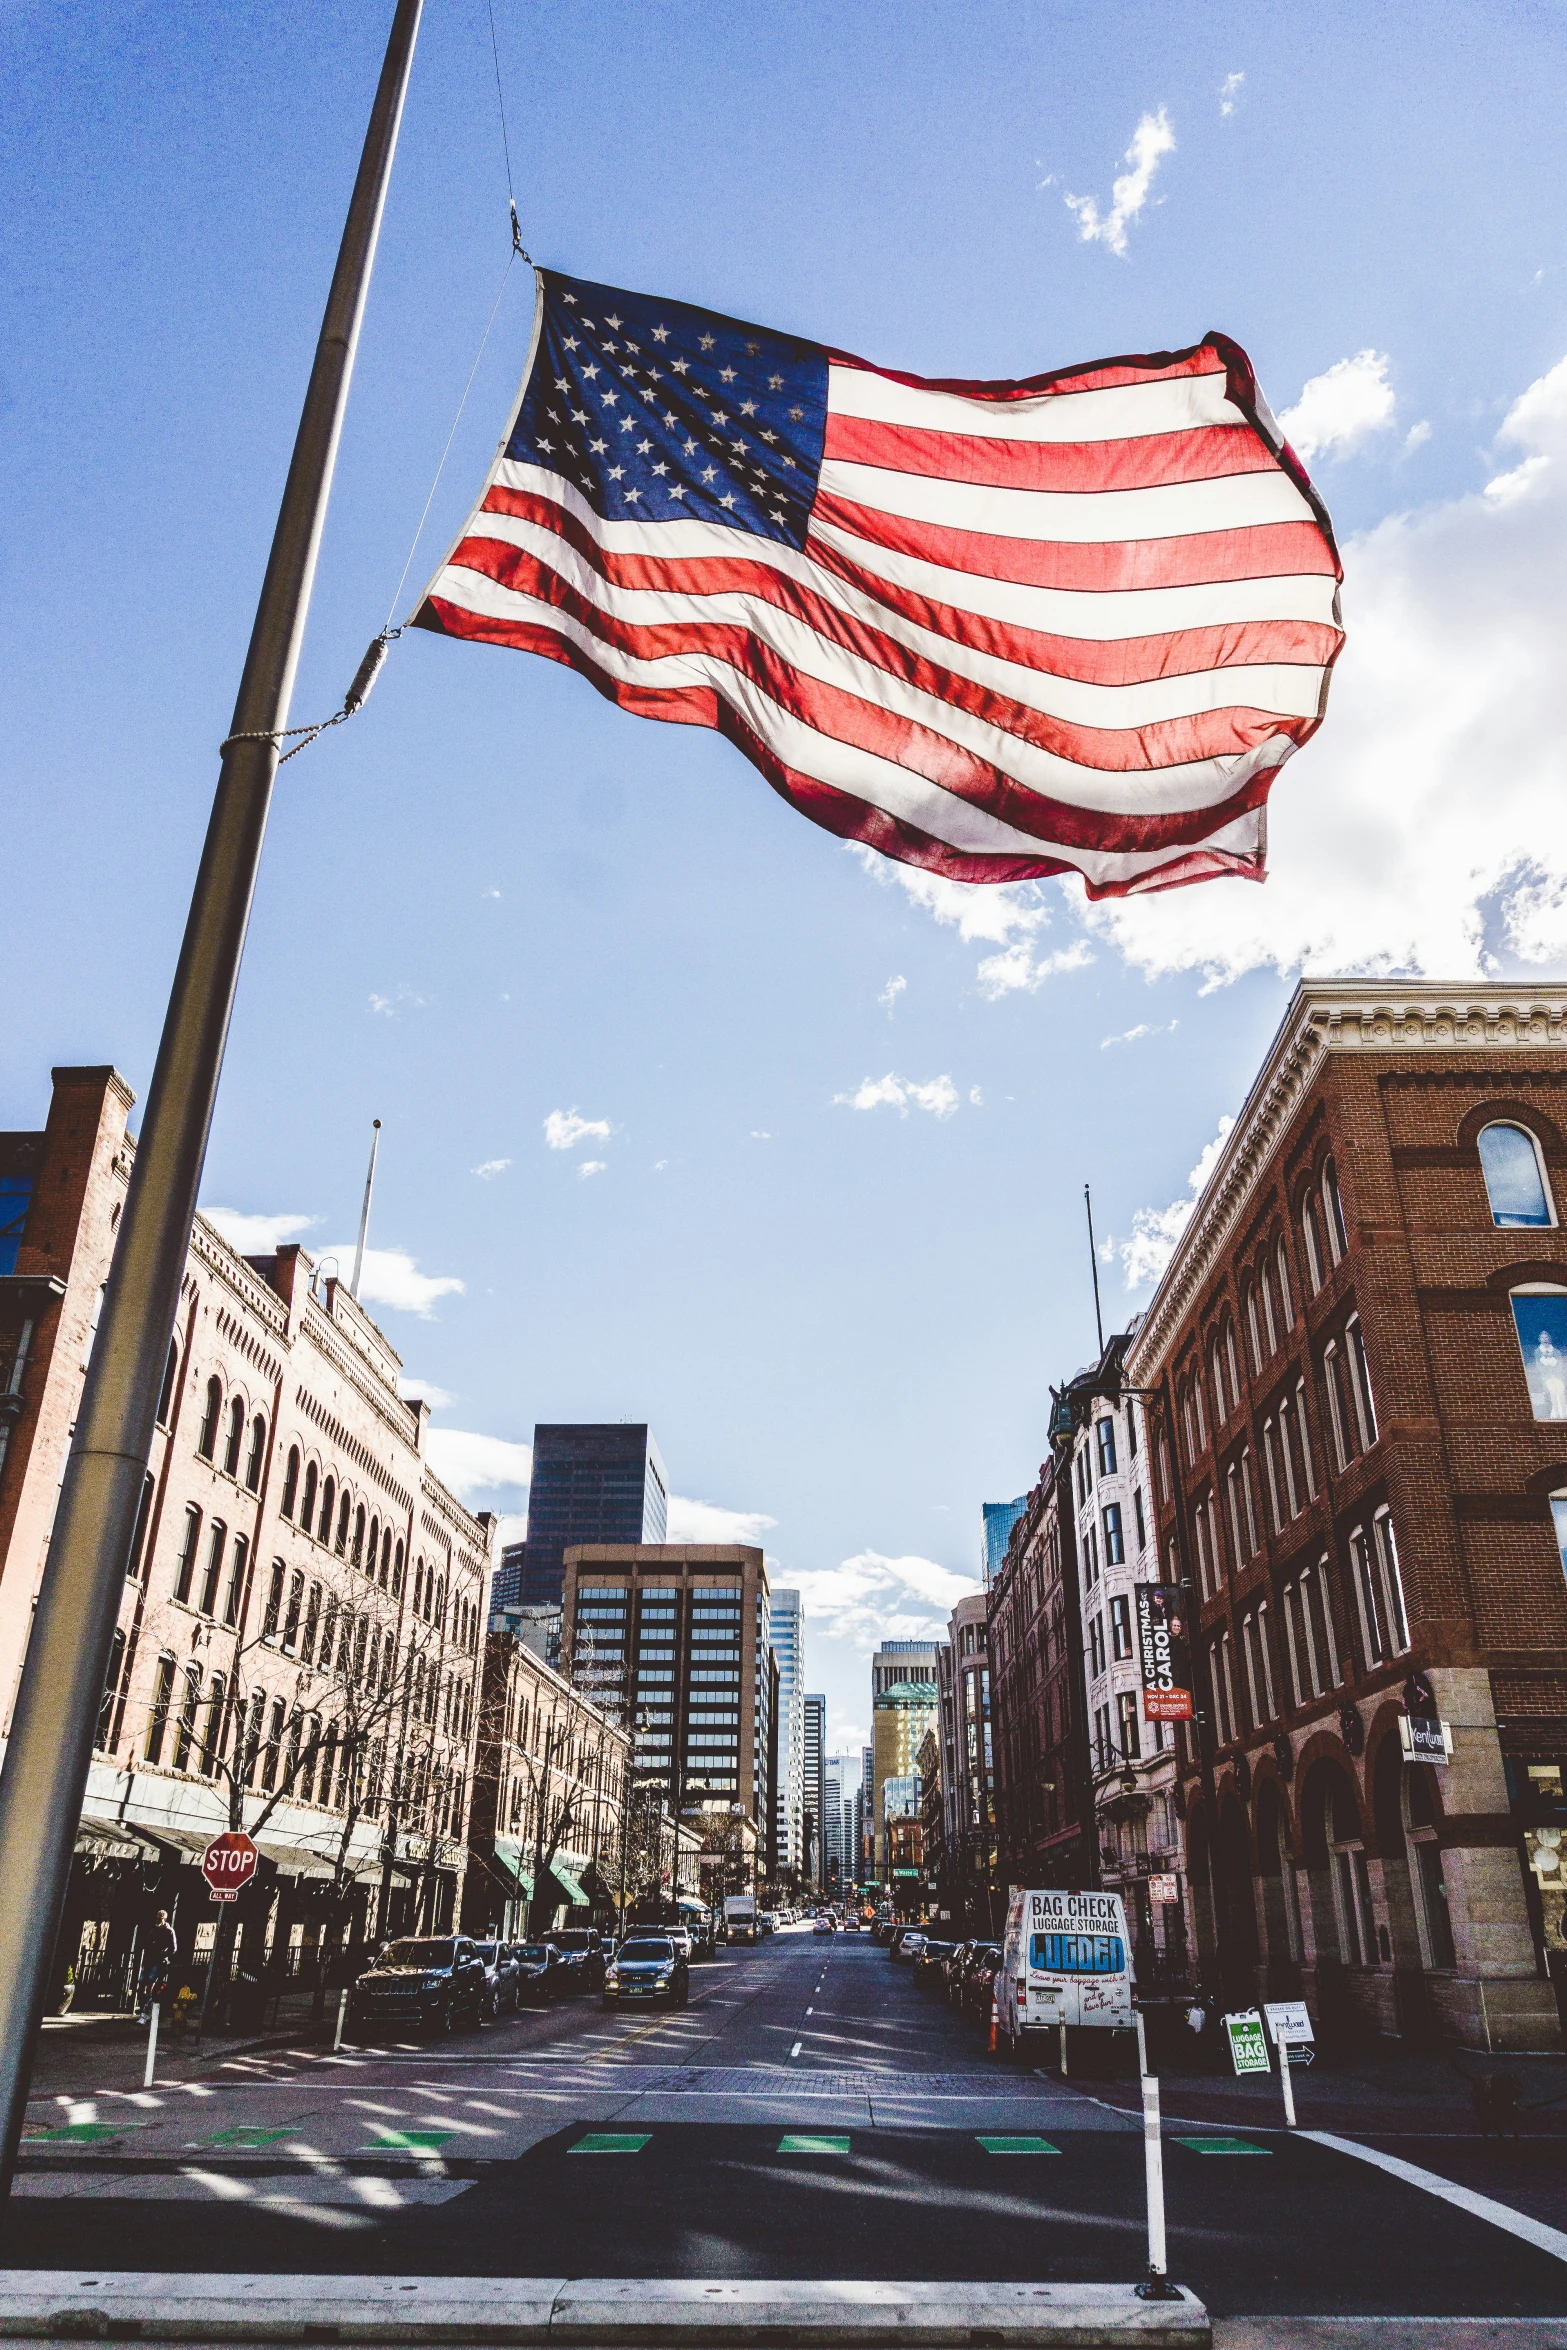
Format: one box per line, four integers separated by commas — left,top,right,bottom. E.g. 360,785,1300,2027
521,1419,670,1607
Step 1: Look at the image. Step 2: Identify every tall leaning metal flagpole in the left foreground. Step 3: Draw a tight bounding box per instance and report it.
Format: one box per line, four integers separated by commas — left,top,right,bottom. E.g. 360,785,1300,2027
0,0,421,2193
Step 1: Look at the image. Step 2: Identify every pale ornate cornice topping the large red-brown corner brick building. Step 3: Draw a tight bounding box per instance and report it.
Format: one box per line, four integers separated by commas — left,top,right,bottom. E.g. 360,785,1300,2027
1125,980,1567,1387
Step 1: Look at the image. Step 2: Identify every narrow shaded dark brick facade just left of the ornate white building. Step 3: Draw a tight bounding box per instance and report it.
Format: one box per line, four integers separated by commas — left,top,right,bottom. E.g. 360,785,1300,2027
987,1447,1097,1892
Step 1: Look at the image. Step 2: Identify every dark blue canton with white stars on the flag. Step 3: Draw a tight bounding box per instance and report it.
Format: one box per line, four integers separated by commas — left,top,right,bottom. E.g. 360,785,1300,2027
505,270,827,548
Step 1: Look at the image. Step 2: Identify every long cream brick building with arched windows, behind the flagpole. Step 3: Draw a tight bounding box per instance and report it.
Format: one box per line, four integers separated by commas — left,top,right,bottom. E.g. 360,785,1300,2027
0,1067,493,2005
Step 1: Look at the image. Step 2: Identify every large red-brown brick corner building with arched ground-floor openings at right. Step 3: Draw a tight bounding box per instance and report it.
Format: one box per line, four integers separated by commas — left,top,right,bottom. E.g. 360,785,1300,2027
1125,980,1567,2049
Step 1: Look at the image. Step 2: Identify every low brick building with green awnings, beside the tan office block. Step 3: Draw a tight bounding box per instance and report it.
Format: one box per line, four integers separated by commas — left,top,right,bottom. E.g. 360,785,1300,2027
463,1631,632,1939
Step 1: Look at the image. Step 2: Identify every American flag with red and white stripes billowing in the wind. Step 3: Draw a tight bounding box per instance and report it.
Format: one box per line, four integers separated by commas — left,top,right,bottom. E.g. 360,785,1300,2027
416,270,1344,898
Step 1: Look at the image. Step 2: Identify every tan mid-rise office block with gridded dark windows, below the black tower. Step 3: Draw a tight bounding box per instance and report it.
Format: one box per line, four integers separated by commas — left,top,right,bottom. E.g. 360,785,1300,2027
561,1542,775,1852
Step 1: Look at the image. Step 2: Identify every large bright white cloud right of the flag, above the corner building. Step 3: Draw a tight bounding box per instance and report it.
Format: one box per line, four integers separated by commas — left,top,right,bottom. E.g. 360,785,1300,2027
1083,360,1567,987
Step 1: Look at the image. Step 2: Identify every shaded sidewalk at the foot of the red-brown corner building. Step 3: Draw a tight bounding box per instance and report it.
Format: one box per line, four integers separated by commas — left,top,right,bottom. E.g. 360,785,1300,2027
1071,2042,1567,2139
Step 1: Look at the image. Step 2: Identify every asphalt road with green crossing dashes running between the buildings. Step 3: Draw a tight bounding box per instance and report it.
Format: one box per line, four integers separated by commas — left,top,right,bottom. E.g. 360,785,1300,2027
2,1932,1567,2315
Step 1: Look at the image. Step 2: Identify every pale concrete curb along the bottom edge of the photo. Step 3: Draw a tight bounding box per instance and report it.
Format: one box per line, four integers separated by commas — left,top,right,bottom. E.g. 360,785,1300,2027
0,2268,1212,2350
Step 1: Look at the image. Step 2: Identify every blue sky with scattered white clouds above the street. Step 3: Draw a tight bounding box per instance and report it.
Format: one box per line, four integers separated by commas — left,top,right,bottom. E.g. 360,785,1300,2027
12,0,1567,1744
